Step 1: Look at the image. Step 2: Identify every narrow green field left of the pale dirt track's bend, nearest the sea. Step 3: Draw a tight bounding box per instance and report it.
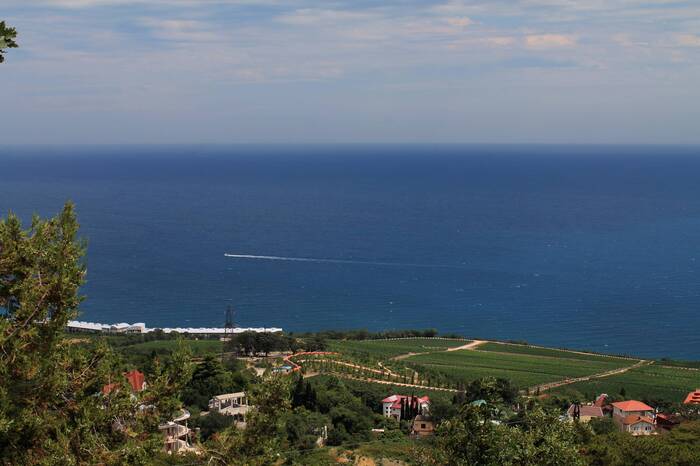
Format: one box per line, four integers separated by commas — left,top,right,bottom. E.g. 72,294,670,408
328,338,469,359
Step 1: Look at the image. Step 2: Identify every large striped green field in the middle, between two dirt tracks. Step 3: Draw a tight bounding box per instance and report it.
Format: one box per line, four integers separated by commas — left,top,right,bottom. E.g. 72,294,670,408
405,350,635,388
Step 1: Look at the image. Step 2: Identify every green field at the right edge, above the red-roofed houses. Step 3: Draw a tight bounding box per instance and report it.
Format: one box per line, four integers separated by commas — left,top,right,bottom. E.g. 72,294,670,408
552,363,700,403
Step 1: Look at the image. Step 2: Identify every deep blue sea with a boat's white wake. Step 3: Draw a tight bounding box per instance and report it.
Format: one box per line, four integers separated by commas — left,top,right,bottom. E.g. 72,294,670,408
0,146,700,358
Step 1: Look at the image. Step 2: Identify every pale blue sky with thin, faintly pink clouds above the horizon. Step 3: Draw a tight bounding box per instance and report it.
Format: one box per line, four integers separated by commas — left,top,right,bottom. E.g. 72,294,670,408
0,0,700,144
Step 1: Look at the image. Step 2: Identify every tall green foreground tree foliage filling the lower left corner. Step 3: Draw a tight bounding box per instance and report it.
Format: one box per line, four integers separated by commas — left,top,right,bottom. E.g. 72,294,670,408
0,203,161,464
